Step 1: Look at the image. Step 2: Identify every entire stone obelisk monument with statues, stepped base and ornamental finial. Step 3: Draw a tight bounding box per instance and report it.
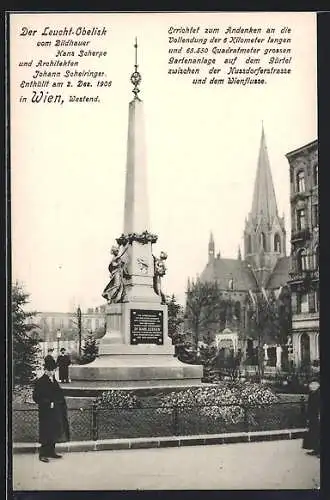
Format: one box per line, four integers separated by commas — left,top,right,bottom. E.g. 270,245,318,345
70,42,202,388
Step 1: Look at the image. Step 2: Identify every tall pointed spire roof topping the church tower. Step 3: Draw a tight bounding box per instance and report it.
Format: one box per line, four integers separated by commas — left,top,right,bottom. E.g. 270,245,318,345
251,124,277,222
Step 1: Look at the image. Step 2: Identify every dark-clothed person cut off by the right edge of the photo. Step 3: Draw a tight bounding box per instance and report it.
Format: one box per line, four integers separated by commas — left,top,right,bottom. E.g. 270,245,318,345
303,379,320,456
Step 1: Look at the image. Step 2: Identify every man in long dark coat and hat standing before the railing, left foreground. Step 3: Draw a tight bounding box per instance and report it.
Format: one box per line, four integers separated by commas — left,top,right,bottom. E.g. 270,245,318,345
33,359,70,462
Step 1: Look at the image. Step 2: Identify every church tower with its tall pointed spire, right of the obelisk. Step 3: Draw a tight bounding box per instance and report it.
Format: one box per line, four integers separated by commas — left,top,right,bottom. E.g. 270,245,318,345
244,126,286,287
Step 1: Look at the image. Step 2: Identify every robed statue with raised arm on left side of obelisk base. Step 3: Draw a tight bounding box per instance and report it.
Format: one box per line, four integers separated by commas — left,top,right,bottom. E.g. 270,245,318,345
102,244,130,304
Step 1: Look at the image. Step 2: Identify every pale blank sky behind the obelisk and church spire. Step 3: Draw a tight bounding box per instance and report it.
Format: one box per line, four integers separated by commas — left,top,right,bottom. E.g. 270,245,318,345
10,12,317,312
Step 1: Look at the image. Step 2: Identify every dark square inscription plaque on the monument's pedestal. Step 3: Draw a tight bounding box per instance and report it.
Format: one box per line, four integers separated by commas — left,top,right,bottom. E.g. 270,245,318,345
130,309,164,345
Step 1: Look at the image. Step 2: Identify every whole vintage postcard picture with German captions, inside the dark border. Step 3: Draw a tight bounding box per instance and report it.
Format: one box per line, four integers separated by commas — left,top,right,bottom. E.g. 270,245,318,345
8,12,320,491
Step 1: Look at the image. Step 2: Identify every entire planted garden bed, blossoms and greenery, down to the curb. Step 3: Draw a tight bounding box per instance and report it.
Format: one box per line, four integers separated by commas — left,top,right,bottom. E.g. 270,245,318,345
13,382,305,442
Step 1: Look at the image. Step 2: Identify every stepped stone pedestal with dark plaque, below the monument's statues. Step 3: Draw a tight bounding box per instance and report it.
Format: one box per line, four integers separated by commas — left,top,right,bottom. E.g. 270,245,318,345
70,302,203,392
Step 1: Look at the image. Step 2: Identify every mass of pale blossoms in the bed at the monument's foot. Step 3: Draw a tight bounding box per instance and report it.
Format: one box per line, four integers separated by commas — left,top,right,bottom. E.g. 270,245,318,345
97,382,278,435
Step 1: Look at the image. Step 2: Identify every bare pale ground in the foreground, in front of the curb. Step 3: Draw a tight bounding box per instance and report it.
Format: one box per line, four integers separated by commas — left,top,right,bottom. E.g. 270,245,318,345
13,439,320,490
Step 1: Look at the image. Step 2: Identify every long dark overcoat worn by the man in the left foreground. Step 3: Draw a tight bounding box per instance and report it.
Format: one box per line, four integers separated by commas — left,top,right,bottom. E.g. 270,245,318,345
33,374,70,444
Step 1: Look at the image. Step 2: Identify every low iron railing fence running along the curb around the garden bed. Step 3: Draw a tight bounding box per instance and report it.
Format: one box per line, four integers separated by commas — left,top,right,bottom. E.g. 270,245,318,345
12,400,306,442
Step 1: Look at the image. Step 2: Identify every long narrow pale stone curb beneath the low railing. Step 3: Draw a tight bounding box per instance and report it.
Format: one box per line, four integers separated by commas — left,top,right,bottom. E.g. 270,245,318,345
13,428,307,454
